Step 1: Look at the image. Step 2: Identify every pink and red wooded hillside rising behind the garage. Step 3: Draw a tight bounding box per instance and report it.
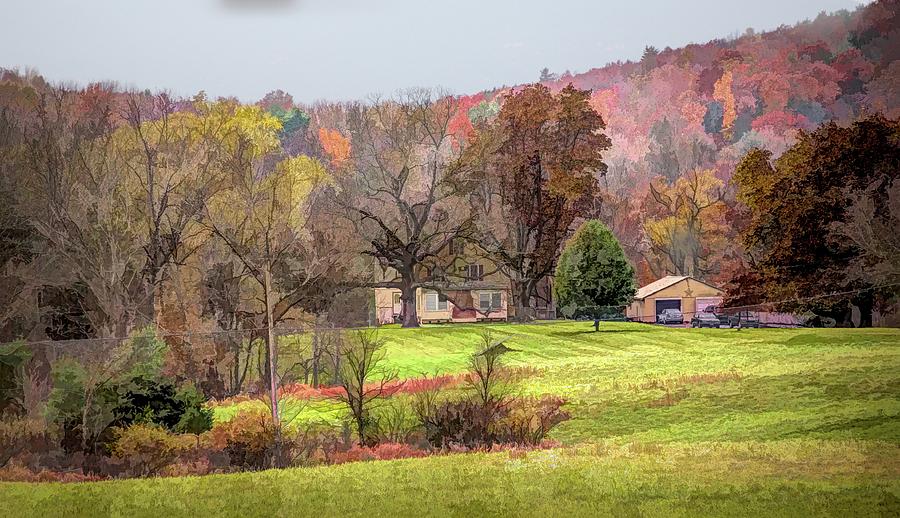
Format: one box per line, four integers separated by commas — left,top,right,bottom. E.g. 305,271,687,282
448,0,900,282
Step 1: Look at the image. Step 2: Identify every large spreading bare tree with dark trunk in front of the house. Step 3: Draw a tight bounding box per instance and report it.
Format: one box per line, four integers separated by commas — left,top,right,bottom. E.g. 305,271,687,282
338,90,472,327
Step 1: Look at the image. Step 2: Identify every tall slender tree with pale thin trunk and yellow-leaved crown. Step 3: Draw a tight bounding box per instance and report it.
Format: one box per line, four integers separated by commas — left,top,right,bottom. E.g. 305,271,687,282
206,105,329,458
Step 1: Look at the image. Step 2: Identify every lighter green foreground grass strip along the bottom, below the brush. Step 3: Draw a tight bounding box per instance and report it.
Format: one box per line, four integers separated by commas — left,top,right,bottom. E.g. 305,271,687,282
0,441,900,517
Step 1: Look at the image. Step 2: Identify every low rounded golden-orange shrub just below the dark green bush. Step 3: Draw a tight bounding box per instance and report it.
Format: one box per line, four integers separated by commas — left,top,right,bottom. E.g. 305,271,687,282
112,424,191,477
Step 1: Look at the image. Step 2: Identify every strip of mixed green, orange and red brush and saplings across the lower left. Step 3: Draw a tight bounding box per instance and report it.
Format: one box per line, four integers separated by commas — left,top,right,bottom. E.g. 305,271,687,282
0,334,569,480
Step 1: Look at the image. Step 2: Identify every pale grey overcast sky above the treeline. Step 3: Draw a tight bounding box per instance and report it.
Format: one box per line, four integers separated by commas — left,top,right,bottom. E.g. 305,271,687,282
0,0,865,103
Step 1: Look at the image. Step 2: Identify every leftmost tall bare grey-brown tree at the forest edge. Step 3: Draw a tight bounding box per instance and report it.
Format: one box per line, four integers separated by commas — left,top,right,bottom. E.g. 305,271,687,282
21,88,150,337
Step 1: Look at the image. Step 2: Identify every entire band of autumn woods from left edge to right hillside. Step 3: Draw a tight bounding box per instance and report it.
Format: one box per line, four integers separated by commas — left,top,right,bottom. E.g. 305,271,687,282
0,1,900,346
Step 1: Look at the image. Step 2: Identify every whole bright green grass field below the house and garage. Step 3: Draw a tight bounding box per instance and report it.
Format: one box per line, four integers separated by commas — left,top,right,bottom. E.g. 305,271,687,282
0,323,900,516
